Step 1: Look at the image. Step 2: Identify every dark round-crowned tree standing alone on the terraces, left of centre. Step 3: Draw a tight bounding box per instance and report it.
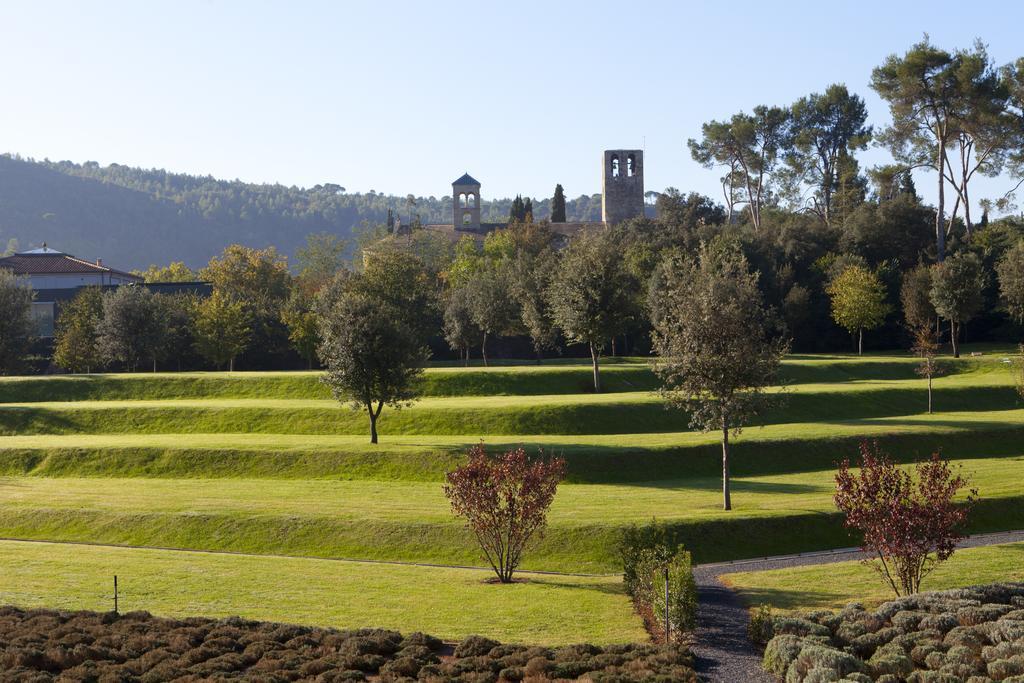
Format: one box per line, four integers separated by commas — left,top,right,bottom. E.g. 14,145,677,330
317,271,430,443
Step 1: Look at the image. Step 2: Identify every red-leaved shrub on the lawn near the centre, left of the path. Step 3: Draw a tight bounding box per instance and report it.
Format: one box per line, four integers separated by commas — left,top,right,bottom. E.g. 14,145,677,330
444,444,565,584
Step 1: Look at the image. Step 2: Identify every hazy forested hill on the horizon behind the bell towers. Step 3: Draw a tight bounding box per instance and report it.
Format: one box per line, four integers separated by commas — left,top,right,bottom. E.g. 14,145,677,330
0,156,601,269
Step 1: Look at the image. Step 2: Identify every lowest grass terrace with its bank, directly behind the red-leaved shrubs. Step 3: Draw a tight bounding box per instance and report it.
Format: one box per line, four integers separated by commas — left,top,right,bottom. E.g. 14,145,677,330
0,448,1024,572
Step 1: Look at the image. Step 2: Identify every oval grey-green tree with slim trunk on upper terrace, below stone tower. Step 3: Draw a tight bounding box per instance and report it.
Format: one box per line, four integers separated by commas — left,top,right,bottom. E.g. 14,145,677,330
548,230,638,393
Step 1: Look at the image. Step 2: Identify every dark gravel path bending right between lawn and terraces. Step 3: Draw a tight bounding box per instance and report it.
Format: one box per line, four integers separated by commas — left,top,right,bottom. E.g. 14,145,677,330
692,530,1024,683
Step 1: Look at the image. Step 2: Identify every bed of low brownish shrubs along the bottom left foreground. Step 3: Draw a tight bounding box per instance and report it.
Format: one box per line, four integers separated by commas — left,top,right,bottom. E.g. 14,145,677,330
0,607,697,683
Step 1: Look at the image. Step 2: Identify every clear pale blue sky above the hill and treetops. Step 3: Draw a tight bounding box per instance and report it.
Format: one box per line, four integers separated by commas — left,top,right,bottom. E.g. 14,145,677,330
0,0,1024,211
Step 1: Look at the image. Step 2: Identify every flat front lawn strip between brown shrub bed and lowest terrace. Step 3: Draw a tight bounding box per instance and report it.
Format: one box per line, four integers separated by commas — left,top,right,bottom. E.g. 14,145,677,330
0,542,646,645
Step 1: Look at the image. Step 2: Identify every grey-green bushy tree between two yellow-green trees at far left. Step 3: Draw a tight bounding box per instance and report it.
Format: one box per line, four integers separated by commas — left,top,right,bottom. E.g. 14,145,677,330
96,285,166,373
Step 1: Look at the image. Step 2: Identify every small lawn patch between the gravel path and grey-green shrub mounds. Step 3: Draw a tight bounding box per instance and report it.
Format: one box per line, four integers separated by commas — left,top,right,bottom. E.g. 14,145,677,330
722,543,1024,610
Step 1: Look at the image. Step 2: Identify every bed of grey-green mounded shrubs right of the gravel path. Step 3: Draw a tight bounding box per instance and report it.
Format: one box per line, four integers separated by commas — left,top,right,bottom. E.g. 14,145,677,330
764,584,1024,683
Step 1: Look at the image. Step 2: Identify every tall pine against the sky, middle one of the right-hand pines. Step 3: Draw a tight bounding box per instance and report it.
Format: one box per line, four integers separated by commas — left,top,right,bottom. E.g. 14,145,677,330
786,84,871,224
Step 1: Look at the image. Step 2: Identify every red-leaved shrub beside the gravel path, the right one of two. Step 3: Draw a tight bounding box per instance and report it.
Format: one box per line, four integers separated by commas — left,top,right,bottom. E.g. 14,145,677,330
835,442,977,596
